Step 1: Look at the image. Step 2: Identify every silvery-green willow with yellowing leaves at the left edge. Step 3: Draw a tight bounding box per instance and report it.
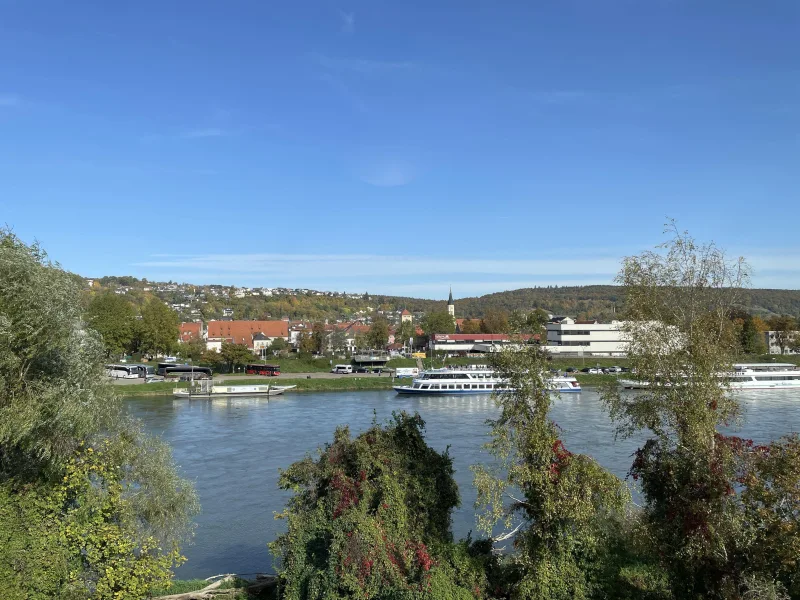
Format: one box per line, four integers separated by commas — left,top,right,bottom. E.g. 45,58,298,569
0,230,196,598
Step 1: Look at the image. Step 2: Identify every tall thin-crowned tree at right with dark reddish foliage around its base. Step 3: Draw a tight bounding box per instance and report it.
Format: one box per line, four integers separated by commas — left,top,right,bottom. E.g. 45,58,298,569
603,226,800,598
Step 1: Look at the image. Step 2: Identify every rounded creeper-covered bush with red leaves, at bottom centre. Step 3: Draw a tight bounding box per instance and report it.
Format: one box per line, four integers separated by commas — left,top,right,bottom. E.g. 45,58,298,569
271,413,492,600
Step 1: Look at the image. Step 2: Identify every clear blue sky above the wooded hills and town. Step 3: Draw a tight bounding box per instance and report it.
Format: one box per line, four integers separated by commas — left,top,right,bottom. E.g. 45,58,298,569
0,0,800,297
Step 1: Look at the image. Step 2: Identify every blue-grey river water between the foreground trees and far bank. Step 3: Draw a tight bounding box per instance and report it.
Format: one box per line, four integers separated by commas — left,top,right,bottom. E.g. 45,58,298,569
127,390,800,579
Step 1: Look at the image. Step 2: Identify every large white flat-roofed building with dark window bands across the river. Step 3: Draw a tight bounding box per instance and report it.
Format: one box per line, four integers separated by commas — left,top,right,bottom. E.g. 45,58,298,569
547,317,628,356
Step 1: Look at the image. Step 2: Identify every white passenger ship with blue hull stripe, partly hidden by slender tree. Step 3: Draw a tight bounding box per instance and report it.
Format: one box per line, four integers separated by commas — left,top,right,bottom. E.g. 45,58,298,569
394,367,581,395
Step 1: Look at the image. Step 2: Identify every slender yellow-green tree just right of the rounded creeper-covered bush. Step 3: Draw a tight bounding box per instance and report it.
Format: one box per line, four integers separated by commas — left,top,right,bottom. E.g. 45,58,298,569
473,346,629,600
